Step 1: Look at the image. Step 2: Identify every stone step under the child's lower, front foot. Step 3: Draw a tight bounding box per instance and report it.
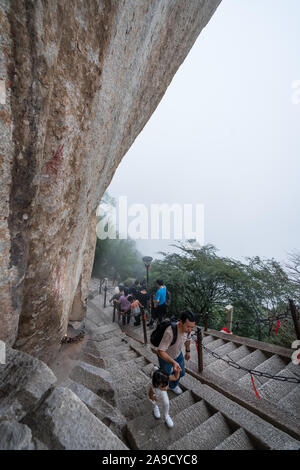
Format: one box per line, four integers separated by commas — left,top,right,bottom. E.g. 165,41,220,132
140,400,212,450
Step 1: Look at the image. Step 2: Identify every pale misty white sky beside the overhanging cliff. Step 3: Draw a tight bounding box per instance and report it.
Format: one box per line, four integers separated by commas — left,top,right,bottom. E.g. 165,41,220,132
108,0,300,261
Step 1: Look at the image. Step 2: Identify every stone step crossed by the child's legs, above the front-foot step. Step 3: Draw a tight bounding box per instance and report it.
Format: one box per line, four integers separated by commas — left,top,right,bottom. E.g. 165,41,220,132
127,391,196,449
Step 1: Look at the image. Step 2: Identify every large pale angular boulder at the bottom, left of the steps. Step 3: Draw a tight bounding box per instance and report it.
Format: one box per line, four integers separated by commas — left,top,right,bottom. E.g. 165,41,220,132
24,387,127,450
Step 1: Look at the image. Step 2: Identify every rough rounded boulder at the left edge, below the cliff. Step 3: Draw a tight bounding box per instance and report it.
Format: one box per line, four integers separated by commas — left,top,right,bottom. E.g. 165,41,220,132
0,345,56,421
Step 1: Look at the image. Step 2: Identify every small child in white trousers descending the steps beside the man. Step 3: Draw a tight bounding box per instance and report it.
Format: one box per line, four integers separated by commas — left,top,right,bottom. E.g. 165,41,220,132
148,369,180,428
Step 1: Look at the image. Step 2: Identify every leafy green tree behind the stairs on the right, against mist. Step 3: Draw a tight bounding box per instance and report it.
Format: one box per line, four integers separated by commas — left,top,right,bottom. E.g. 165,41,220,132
150,243,299,346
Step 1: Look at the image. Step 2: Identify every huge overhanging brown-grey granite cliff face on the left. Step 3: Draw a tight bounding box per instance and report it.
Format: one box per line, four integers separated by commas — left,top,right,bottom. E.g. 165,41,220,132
0,0,221,362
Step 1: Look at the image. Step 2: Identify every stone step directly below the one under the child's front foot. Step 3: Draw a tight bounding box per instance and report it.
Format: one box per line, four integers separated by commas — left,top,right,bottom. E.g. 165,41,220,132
168,412,231,450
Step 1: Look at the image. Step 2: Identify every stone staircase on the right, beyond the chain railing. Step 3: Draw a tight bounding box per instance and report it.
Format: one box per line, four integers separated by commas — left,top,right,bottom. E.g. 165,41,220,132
127,310,300,436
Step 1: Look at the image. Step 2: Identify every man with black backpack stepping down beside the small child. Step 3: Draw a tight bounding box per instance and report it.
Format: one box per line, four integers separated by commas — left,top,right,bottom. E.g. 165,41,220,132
151,310,196,395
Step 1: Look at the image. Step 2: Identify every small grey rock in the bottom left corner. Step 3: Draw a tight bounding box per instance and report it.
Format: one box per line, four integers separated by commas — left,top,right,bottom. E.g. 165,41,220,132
0,421,34,450
